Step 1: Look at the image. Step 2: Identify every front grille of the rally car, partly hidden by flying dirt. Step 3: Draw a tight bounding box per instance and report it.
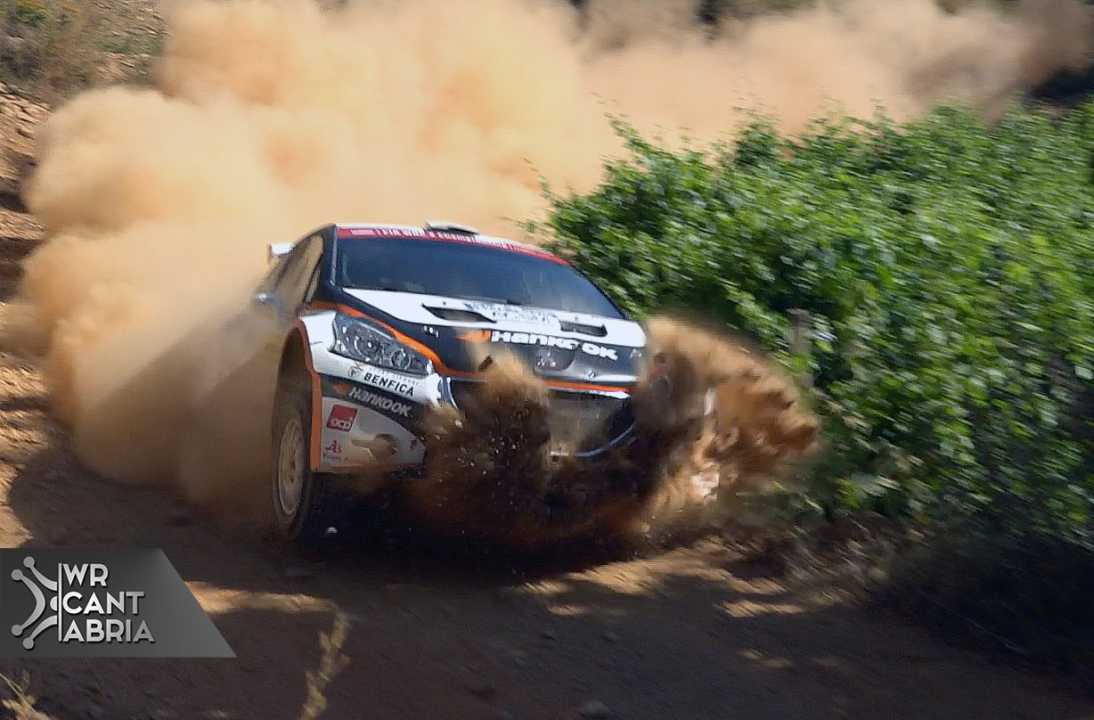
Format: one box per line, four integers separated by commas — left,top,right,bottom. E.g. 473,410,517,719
451,380,633,454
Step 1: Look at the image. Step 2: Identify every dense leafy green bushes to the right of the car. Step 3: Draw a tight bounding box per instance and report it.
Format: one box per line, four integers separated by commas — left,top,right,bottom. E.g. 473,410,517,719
549,103,1094,547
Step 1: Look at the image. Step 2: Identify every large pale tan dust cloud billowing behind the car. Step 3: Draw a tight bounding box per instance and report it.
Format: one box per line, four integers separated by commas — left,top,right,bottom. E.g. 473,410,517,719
10,0,1092,518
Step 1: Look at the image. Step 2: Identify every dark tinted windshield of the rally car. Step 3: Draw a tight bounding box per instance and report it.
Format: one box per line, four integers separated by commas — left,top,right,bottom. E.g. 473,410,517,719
336,237,621,317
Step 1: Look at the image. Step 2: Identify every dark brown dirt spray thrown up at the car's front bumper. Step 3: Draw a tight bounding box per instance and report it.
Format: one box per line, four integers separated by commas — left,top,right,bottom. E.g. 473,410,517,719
407,316,819,548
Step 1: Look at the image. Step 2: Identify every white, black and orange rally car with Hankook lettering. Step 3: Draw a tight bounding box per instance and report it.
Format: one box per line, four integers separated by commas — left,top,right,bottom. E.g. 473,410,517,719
255,222,647,539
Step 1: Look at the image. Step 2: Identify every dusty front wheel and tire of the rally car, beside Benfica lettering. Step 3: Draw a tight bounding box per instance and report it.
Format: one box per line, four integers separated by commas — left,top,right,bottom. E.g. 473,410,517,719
270,372,335,545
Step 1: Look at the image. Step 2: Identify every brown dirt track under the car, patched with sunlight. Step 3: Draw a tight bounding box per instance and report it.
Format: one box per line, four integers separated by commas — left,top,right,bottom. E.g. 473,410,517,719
0,215,1094,720
